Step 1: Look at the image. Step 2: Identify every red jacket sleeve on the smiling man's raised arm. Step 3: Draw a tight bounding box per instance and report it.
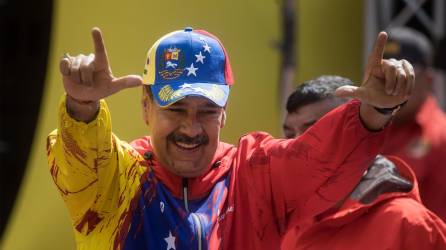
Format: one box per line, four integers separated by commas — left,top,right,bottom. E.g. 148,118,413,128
241,100,387,234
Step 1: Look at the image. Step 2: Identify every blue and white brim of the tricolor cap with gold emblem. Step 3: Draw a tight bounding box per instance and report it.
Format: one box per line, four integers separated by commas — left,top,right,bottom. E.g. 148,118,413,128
150,83,229,107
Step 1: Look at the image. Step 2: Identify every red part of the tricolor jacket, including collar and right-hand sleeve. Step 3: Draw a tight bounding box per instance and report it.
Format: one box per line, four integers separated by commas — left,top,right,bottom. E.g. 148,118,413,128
126,101,385,249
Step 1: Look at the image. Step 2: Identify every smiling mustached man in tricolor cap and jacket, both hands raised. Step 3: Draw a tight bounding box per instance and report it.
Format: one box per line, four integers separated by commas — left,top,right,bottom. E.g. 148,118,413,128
48,28,414,249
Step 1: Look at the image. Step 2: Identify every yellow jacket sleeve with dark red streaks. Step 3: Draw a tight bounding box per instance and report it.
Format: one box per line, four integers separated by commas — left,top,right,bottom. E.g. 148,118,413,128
47,96,137,234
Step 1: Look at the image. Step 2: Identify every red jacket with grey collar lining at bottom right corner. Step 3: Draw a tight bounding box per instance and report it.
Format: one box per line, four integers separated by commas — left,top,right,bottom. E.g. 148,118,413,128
282,156,446,250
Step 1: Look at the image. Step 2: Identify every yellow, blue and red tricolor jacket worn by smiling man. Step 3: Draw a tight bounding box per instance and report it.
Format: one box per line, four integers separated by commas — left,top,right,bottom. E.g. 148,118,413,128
48,96,387,250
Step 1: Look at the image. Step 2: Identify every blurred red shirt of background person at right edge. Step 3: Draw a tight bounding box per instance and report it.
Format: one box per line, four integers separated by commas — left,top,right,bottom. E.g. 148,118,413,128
383,96,446,221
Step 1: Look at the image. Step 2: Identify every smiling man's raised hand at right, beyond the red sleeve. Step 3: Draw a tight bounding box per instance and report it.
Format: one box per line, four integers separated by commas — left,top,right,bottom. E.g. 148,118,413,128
335,32,415,108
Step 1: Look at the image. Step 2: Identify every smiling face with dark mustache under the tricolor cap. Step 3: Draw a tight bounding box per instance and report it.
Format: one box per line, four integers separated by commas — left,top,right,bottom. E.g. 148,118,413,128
145,96,225,177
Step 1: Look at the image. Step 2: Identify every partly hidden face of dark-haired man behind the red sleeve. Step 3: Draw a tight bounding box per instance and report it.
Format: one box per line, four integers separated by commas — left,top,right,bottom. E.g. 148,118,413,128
283,98,338,139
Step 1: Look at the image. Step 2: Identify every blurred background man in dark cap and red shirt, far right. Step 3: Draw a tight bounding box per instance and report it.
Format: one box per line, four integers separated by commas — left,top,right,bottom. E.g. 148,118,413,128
383,28,446,221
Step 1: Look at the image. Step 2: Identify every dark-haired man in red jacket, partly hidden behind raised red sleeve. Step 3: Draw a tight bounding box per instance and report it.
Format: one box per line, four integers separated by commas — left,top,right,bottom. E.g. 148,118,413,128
282,76,446,250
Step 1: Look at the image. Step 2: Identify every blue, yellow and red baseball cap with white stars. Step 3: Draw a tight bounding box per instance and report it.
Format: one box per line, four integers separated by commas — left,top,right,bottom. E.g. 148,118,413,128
143,27,234,107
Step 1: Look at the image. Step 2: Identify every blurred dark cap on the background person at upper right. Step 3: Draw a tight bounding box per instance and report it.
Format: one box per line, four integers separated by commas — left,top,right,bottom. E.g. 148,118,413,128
384,27,432,66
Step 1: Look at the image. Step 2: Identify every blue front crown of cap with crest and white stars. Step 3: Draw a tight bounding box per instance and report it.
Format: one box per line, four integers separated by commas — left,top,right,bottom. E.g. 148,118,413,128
154,28,226,85
